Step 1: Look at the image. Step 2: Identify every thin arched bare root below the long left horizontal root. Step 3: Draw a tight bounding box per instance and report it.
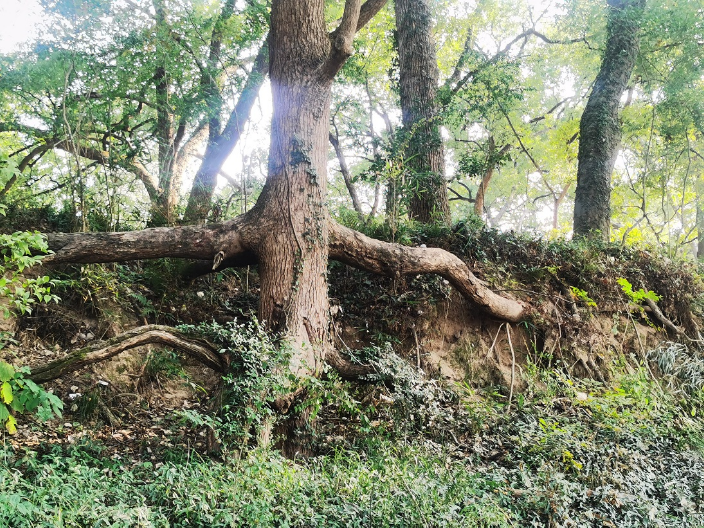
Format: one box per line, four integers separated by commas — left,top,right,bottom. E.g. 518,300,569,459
29,325,227,383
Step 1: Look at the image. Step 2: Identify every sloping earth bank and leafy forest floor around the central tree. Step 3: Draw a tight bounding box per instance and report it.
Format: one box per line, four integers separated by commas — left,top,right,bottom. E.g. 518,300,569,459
0,225,704,527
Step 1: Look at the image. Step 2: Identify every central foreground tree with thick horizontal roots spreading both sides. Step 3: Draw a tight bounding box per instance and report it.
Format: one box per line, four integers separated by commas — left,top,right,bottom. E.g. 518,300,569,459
44,0,525,380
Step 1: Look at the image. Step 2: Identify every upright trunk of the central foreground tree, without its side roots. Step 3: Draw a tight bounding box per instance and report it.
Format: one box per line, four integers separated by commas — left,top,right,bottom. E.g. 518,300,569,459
246,0,332,373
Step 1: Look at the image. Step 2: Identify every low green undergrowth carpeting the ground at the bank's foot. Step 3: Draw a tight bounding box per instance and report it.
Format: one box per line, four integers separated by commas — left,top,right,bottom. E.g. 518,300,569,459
0,360,704,527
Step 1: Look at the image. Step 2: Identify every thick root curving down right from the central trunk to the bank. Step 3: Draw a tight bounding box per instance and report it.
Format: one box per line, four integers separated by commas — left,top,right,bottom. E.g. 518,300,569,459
329,222,526,322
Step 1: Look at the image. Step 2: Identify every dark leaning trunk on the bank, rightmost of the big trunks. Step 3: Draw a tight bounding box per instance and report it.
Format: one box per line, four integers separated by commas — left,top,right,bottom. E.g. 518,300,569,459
574,0,645,241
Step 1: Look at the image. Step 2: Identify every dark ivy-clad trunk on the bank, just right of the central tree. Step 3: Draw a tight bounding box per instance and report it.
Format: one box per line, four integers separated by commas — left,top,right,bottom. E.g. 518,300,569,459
396,0,450,223
